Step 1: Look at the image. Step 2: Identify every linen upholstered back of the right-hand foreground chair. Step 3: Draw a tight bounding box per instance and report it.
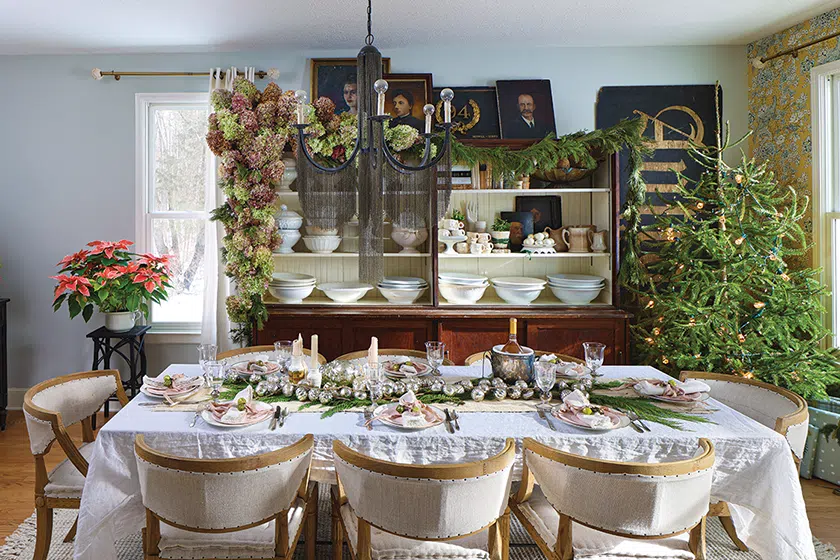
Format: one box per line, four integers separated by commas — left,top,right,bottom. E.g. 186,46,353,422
523,438,715,537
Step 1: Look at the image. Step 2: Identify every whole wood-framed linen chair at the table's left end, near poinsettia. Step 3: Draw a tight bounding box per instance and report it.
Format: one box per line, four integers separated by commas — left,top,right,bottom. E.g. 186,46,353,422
23,369,128,560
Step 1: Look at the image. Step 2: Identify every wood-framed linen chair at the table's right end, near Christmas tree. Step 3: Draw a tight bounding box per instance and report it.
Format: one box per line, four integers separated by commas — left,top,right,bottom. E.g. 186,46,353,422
680,371,808,551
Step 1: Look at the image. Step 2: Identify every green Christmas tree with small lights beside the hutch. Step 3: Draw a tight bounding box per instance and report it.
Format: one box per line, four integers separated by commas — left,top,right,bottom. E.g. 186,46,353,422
631,127,840,398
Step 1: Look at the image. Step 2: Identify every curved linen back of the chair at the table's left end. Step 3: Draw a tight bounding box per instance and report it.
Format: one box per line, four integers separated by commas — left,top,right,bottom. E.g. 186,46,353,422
23,369,125,455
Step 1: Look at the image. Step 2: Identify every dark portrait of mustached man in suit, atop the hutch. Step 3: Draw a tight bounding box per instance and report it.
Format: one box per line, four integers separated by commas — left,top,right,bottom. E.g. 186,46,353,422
496,80,557,139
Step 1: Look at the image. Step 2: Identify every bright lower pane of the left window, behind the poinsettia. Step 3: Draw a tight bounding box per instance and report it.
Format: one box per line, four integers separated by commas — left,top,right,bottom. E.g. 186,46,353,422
151,219,205,324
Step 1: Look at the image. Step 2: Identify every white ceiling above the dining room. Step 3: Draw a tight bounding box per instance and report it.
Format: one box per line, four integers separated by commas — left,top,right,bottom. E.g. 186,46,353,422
0,0,840,54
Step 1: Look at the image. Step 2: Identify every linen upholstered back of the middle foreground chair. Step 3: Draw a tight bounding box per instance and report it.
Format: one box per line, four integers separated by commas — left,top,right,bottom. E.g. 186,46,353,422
333,439,515,540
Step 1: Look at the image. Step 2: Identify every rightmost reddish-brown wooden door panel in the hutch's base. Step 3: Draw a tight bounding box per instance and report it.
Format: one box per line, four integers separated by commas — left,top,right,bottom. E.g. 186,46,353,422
526,319,625,365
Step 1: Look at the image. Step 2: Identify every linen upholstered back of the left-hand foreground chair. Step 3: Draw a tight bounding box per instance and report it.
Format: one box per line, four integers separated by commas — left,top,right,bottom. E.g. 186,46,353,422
134,435,313,531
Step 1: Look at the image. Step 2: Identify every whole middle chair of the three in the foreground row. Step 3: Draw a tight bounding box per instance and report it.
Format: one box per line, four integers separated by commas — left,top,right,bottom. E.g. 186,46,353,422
332,439,515,560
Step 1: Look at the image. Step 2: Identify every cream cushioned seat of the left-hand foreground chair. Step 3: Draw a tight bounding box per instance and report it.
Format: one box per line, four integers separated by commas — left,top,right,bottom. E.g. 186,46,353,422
158,498,306,560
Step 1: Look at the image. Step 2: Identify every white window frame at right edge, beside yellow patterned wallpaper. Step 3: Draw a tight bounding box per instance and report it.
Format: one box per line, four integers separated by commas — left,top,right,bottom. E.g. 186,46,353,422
811,60,840,347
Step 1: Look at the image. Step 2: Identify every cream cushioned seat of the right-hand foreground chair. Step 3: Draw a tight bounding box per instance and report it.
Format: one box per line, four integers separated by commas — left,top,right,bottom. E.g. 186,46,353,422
519,485,694,560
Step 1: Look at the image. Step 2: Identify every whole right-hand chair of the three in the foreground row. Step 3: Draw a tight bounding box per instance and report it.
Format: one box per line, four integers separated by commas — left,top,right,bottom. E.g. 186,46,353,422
510,438,715,560
